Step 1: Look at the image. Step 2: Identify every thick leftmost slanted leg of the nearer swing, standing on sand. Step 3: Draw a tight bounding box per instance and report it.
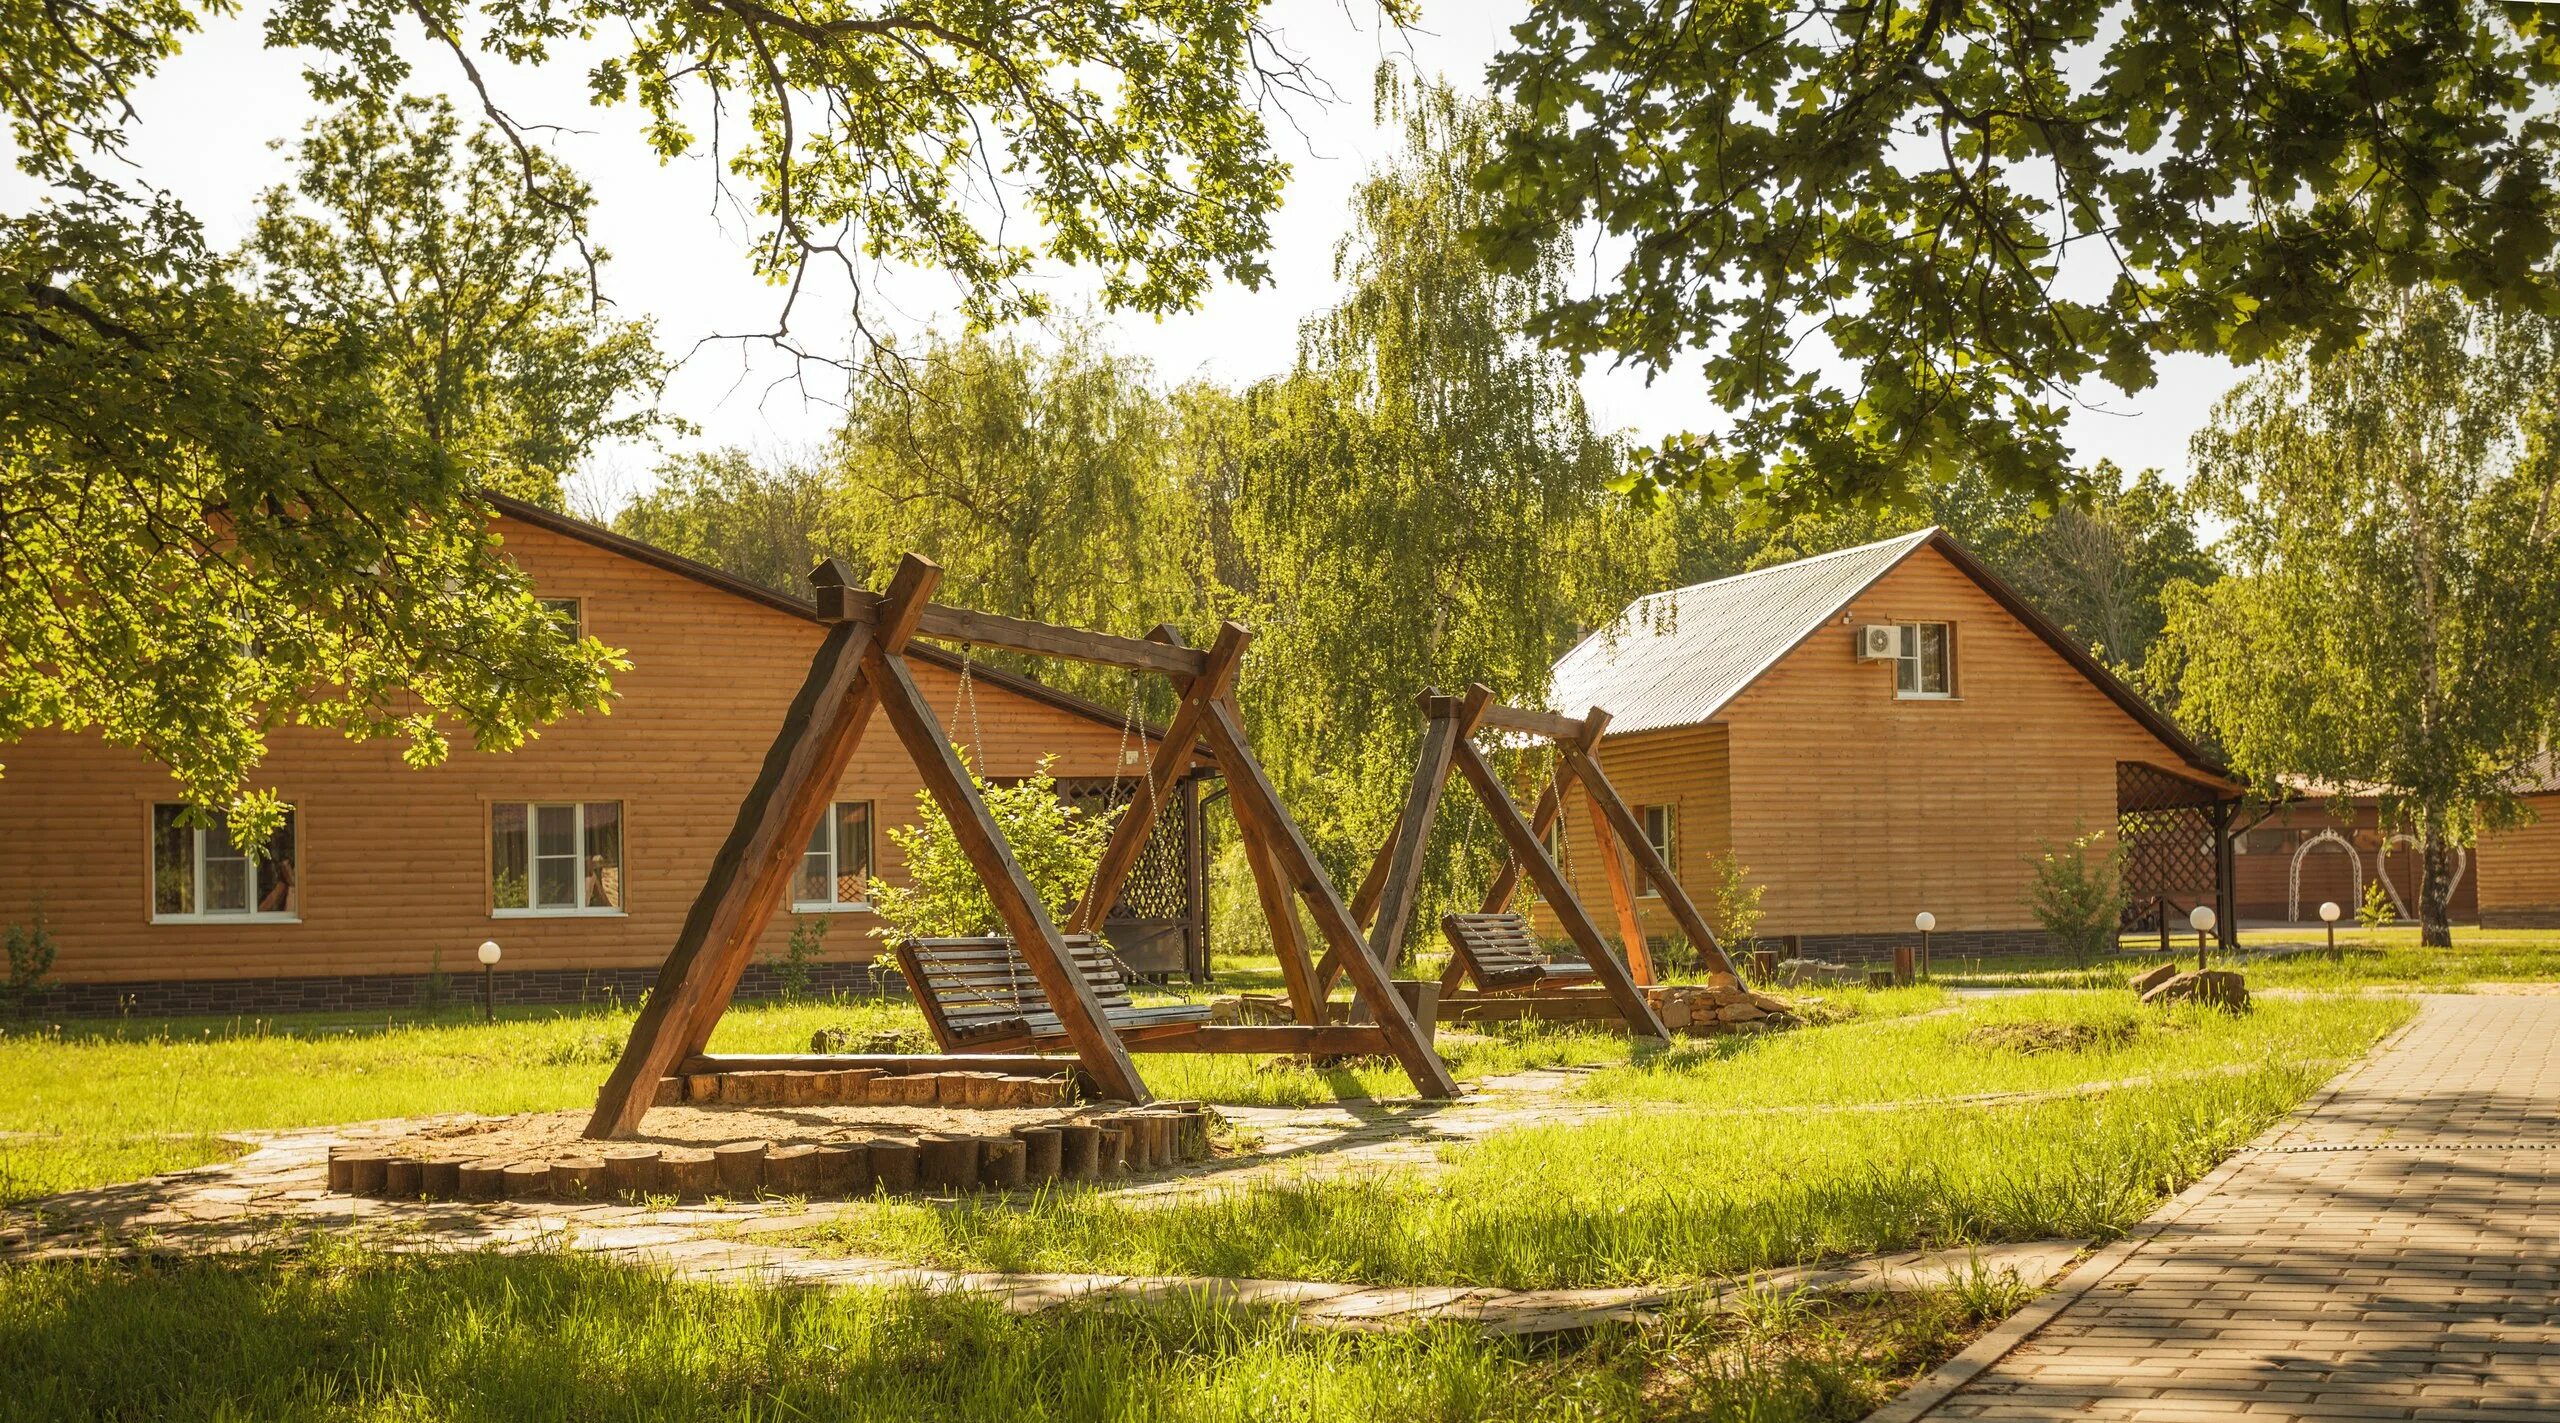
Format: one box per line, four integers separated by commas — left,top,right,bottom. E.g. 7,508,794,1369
586,601,873,1136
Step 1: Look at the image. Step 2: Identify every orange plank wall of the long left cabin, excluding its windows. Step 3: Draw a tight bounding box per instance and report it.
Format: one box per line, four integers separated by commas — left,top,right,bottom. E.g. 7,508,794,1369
0,517,1172,1011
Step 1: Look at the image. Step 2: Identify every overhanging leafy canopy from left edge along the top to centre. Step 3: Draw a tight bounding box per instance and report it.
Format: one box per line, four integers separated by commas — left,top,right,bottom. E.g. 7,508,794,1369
0,0,1361,824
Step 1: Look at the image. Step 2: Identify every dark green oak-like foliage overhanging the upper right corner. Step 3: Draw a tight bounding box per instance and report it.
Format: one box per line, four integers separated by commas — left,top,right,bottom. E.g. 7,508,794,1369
1482,0,2560,512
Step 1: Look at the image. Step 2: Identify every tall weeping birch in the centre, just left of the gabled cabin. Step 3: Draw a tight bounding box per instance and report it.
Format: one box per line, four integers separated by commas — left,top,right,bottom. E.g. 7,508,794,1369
1226,84,1644,890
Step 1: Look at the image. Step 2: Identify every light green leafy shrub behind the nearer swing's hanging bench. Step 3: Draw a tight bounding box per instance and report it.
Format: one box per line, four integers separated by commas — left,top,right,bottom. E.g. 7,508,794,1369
870,758,1119,939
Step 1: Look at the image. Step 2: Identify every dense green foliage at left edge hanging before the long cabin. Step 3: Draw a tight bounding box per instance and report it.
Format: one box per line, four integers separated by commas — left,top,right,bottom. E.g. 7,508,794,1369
0,105,658,842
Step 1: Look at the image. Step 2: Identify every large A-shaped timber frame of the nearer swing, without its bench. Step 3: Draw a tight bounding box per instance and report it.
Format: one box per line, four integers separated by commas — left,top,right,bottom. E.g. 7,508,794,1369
586,553,1459,1139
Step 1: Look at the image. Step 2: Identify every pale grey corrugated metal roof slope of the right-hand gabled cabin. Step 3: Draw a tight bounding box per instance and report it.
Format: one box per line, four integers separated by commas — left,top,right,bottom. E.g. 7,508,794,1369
1546,527,1938,732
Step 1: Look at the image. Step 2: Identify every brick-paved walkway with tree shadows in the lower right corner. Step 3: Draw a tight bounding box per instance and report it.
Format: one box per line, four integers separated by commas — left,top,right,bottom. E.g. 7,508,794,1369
1928,996,2560,1423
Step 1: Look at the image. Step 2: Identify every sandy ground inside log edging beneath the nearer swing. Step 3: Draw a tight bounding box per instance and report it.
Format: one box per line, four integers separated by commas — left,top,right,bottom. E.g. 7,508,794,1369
381,1106,1121,1159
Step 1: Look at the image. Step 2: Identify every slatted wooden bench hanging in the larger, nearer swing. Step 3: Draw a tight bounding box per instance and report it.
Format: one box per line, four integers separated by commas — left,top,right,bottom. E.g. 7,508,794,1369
899,934,1208,1052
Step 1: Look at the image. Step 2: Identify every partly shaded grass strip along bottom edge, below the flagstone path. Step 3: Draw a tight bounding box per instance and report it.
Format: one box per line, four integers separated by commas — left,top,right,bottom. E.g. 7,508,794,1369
0,1246,2017,1423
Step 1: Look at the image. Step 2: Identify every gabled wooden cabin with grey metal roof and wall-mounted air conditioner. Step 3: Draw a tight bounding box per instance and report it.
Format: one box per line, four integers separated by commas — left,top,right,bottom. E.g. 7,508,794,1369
1549,530,2237,960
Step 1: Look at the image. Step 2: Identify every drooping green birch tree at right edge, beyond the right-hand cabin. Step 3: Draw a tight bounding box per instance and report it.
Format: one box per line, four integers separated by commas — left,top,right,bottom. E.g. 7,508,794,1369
2156,287,2560,944
